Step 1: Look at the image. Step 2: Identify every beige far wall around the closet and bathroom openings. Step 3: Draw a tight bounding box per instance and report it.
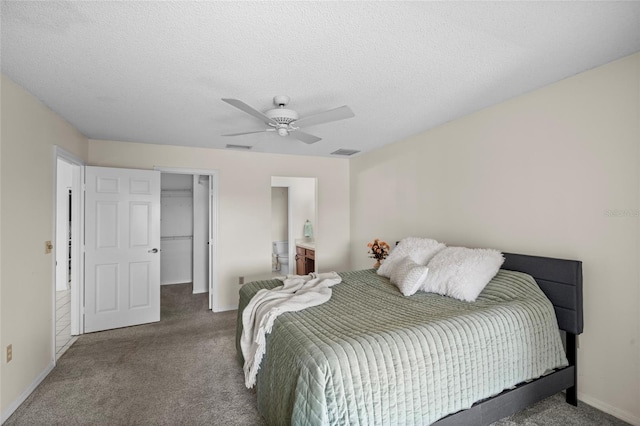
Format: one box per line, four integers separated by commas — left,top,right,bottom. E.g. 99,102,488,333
89,140,350,309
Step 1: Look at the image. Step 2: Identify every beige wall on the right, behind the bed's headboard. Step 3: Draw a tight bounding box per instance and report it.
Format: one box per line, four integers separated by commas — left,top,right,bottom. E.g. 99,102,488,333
350,54,640,424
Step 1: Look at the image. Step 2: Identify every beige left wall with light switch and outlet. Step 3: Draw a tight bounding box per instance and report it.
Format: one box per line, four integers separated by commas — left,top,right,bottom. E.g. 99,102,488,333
0,75,87,413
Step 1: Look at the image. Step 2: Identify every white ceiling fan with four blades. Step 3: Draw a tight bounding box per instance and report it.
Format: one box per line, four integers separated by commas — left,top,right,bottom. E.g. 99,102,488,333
222,95,355,144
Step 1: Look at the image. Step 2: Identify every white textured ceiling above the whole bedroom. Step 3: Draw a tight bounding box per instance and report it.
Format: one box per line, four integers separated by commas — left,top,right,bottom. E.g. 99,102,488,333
0,1,640,156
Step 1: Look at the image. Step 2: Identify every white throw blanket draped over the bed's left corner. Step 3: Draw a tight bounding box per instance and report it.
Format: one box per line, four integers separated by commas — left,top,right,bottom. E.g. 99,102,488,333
240,272,342,388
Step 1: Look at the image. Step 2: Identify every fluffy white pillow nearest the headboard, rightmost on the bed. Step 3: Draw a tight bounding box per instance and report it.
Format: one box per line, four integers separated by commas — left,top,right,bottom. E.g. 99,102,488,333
420,247,504,302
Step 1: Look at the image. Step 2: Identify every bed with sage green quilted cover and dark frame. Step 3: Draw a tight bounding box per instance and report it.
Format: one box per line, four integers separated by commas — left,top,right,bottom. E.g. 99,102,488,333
237,253,583,425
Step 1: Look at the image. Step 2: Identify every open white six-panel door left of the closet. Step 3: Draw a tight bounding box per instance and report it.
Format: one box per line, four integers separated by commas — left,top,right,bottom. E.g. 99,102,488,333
84,167,160,333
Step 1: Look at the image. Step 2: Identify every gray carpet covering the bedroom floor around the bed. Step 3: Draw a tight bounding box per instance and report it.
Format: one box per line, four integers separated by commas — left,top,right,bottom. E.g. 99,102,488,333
5,284,626,426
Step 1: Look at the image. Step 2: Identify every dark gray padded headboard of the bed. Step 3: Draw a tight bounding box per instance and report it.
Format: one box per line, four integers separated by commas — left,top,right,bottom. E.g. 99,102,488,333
502,253,583,334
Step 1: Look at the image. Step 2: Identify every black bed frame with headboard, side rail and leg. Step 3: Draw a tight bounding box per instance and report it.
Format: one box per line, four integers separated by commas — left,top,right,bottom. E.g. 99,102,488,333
434,253,583,426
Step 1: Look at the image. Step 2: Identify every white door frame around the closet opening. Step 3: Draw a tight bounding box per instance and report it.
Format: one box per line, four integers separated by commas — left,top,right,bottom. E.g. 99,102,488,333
153,166,219,312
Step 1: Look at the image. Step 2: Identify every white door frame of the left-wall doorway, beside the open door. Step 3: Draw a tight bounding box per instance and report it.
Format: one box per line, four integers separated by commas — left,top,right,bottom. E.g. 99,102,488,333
51,145,86,356
